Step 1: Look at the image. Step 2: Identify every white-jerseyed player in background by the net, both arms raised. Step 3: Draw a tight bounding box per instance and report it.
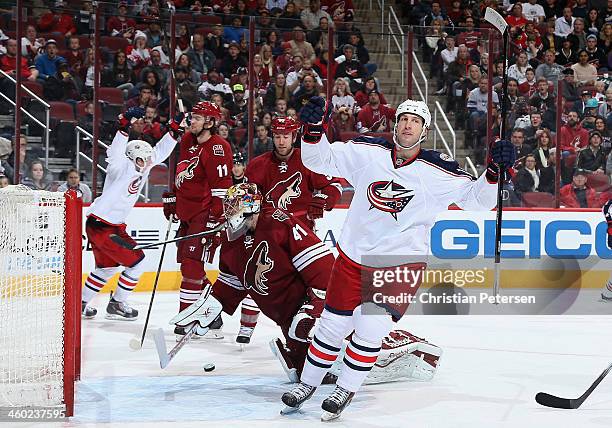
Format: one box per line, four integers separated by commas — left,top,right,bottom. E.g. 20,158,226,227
81,107,183,320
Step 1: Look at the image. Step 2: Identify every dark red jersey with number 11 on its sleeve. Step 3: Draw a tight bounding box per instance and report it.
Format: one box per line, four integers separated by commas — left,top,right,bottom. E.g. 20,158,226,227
174,133,233,221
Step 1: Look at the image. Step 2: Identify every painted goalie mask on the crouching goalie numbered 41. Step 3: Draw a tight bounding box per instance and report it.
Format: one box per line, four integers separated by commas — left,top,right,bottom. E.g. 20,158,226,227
223,183,261,241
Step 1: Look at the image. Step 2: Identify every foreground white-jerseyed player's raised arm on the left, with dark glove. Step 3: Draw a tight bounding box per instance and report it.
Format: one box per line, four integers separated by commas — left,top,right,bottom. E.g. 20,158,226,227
300,97,367,183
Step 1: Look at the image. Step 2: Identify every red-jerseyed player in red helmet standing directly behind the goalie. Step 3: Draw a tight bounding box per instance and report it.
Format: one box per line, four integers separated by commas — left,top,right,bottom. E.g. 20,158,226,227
236,116,342,343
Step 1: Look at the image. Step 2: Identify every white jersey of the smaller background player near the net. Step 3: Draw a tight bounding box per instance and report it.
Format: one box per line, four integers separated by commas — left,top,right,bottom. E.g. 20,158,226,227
87,131,176,225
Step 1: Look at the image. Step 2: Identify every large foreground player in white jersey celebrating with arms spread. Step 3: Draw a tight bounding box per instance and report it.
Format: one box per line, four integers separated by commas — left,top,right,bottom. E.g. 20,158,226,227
282,97,514,421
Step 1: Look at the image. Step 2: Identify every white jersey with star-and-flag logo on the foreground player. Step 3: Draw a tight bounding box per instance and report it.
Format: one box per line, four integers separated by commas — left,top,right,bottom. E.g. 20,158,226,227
301,135,497,267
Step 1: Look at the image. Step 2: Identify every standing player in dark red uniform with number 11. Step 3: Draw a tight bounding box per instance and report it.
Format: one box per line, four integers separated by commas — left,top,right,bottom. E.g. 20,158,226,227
163,101,233,335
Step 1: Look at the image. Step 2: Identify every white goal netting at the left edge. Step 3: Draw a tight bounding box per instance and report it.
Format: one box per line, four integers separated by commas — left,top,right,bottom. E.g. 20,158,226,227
0,186,65,407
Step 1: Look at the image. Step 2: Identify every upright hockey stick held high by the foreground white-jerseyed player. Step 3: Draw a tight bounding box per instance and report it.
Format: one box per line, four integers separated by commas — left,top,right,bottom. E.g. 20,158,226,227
485,7,508,301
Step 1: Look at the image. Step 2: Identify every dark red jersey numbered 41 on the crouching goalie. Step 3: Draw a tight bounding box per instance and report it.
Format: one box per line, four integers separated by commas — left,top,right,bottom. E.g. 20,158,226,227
213,207,334,326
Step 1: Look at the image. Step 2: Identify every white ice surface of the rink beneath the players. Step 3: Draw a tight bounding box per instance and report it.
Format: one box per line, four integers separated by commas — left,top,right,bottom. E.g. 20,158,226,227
25,292,612,428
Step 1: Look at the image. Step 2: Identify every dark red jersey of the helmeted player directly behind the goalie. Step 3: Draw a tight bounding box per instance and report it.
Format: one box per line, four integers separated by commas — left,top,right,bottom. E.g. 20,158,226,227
244,149,342,225
